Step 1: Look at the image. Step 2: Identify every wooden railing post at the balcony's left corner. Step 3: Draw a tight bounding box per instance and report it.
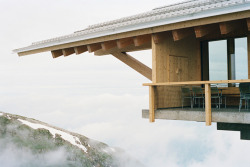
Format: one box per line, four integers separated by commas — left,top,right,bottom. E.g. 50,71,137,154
149,86,155,122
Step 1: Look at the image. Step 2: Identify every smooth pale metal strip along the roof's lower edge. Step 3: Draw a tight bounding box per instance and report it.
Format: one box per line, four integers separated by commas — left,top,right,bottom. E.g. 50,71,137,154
13,3,250,53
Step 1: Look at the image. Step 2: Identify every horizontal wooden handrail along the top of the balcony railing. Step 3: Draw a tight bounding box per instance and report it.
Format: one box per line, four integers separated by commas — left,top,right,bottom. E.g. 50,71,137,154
143,79,250,86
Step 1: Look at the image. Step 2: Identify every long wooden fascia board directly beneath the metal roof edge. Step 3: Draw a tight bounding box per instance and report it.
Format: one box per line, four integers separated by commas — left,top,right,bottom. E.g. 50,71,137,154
18,10,250,56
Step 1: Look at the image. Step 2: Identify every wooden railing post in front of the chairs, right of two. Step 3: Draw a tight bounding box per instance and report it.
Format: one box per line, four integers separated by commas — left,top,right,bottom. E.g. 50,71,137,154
205,84,212,126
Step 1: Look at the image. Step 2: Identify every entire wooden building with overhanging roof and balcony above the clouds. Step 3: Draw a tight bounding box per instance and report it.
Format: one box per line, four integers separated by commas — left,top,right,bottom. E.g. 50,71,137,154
14,0,250,139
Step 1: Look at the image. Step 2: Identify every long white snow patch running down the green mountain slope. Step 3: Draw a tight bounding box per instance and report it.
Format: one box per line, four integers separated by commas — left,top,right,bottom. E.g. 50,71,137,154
17,119,88,153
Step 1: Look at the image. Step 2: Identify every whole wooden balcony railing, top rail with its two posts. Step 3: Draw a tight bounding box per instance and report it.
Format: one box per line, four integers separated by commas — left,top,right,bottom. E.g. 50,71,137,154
143,79,250,126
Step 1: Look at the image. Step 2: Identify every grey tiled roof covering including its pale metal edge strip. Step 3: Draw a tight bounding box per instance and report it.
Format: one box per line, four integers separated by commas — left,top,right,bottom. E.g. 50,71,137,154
14,0,250,53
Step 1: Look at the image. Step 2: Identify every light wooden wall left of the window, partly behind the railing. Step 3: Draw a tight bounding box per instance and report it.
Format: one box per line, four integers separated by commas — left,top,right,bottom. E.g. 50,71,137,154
152,32,201,108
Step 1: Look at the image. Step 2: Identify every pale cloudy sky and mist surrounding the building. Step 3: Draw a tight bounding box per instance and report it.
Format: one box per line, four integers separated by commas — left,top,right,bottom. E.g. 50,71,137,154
0,0,250,167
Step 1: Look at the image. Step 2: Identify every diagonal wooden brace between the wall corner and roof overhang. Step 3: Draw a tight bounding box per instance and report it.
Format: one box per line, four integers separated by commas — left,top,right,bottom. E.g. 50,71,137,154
111,53,152,80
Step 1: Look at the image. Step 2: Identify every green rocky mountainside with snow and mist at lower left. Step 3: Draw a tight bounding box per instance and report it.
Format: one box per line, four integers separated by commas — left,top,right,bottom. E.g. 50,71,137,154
0,112,143,167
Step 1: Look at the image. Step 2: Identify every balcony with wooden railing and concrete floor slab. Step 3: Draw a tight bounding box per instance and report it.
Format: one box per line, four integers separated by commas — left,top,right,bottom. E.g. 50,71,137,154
143,79,250,126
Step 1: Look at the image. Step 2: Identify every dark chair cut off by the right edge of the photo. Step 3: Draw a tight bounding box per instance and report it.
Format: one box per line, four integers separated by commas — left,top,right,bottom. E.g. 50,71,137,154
239,83,250,112
